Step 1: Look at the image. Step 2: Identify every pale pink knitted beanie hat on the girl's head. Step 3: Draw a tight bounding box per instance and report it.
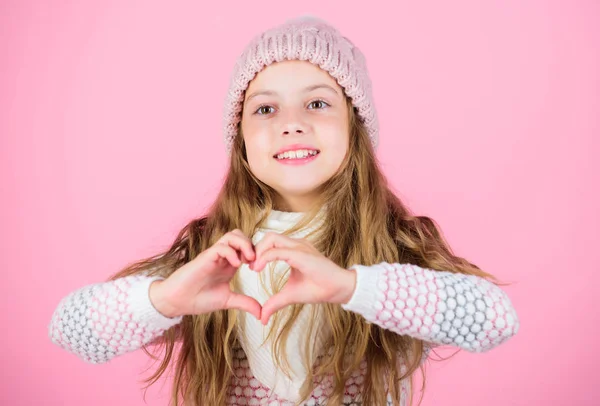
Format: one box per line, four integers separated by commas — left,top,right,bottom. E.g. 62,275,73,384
223,16,379,155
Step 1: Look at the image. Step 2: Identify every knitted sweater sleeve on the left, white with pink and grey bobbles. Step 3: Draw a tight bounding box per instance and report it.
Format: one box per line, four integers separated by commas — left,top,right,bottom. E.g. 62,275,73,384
48,274,182,364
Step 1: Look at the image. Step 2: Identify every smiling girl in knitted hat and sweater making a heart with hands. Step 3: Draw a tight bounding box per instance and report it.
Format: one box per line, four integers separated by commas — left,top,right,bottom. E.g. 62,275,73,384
49,18,519,406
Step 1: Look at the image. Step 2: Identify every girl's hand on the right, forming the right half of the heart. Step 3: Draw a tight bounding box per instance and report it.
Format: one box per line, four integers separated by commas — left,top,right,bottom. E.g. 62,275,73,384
250,232,356,325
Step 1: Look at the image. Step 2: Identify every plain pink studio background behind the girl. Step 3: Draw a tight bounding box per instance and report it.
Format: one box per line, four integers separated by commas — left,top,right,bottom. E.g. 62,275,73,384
0,0,600,406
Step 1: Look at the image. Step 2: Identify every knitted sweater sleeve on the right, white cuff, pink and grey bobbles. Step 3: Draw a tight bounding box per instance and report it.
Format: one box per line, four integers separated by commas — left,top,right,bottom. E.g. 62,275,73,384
342,262,519,352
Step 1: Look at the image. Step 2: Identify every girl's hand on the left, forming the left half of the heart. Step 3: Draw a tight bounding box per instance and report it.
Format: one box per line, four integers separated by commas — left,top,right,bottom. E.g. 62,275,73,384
149,229,261,320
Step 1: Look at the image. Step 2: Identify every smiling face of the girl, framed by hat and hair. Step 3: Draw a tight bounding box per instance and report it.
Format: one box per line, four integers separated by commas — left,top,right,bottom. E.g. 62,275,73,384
241,61,349,211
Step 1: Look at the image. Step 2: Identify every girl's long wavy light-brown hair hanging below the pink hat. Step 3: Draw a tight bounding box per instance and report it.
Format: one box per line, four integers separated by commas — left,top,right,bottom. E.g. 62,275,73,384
111,101,499,406
